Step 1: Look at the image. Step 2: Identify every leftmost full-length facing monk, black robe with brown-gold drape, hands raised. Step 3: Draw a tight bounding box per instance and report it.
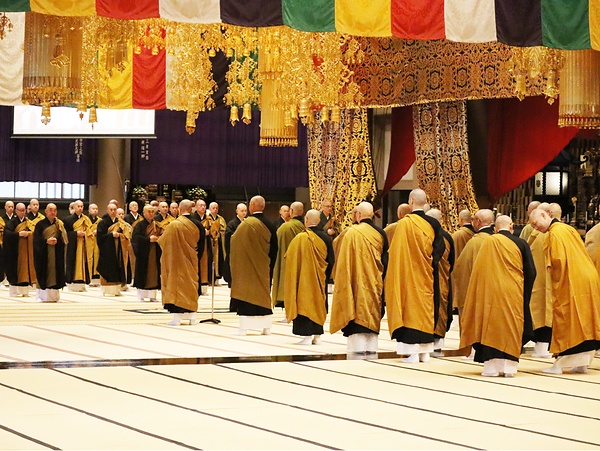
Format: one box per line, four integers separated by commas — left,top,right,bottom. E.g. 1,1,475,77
4,202,36,297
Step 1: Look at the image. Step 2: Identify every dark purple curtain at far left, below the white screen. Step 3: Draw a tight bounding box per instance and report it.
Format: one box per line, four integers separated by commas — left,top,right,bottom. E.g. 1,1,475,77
0,106,98,185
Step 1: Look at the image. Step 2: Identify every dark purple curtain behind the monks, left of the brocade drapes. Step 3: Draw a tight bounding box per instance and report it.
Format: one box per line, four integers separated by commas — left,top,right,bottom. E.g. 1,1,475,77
131,109,308,188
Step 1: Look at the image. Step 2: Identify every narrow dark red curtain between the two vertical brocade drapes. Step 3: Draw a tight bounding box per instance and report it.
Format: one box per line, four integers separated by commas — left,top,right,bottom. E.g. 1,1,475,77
381,106,415,196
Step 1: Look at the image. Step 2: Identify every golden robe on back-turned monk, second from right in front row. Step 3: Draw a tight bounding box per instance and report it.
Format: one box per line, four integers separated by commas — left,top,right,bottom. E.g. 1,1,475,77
460,234,525,359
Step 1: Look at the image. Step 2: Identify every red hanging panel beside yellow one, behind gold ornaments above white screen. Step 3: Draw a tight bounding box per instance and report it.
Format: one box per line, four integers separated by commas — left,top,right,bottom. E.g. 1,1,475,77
132,48,167,110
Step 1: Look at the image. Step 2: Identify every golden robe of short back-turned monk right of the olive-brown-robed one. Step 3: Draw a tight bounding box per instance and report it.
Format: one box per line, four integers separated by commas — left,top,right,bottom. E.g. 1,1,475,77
278,231,327,326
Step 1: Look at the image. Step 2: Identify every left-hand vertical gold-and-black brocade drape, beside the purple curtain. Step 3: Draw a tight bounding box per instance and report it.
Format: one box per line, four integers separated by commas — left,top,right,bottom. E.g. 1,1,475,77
308,109,377,228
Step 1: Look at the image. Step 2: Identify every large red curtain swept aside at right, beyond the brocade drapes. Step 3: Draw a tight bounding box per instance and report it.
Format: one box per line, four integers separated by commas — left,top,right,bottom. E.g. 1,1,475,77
488,97,578,202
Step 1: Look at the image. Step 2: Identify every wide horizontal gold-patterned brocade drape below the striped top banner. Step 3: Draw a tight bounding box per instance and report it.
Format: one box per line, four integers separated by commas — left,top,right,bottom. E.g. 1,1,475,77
349,38,545,107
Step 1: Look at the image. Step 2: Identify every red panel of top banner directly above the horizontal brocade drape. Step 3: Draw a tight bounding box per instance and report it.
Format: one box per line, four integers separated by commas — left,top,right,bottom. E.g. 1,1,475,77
392,0,446,40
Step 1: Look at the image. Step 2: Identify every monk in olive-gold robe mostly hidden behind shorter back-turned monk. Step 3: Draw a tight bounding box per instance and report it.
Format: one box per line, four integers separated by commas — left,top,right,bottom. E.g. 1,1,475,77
271,202,308,307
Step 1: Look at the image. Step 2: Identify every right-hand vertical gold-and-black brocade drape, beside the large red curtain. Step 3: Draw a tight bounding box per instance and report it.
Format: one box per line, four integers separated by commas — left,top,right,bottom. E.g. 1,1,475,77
413,101,478,231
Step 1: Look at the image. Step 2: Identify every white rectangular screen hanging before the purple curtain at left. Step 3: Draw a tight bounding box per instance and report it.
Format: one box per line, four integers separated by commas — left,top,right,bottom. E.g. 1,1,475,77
13,106,155,138
